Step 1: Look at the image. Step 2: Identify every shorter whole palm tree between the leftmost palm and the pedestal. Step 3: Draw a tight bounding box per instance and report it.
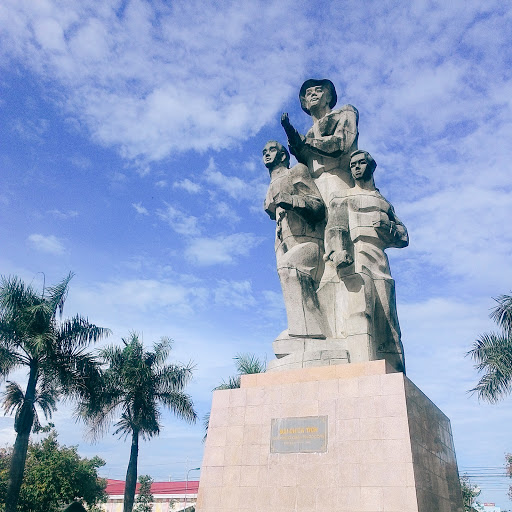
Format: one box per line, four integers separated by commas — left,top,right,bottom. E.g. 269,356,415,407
78,333,196,512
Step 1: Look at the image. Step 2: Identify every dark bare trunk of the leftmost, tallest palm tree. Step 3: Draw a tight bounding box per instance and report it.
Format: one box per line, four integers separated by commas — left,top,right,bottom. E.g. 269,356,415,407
5,365,38,512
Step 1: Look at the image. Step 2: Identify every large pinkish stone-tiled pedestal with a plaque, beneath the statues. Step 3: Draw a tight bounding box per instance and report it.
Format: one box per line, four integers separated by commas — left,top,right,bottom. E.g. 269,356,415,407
196,360,463,512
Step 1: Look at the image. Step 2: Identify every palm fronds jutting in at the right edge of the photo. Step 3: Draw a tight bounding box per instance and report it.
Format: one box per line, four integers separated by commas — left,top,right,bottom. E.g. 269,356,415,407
467,295,512,403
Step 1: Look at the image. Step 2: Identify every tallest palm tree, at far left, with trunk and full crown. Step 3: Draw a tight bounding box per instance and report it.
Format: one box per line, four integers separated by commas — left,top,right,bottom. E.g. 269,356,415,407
0,273,110,512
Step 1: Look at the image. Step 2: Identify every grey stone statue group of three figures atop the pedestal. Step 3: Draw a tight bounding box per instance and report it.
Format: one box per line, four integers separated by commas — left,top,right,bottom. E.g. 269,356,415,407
263,79,409,371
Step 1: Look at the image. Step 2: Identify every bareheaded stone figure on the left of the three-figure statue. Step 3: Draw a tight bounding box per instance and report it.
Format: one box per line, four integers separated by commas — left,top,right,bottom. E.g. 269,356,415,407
263,141,325,338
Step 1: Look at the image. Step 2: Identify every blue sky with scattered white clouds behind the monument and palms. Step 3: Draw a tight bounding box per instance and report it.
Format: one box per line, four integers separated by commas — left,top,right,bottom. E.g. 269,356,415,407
0,0,512,508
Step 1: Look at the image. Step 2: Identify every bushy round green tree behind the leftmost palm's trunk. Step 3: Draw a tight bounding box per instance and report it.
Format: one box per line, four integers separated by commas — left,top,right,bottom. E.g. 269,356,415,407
0,431,107,512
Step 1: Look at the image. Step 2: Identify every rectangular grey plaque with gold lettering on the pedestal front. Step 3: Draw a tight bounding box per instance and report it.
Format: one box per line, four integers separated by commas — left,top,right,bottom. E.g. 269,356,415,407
270,416,327,453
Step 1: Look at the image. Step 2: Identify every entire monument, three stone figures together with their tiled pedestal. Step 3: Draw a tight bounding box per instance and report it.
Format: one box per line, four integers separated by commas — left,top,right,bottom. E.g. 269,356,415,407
197,79,463,512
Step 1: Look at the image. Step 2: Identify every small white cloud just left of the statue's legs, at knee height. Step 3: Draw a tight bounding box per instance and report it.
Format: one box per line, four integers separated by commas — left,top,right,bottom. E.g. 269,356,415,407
185,233,262,266
